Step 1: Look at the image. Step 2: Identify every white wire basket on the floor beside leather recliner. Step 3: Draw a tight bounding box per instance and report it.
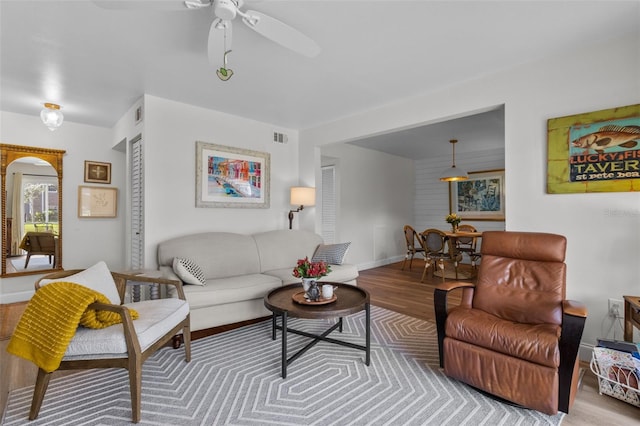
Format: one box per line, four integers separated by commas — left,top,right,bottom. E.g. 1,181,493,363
591,354,640,407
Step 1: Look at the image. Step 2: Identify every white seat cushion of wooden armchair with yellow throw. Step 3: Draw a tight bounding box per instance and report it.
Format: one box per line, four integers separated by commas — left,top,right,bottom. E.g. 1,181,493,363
63,298,189,361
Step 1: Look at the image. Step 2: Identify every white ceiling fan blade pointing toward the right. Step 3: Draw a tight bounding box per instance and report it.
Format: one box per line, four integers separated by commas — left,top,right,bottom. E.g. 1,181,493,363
242,10,322,58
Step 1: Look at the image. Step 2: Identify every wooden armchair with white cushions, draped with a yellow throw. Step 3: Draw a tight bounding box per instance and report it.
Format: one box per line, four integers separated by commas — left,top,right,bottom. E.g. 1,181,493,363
29,262,191,423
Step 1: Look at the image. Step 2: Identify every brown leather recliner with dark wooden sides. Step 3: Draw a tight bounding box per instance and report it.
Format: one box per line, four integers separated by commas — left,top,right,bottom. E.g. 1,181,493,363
434,231,587,415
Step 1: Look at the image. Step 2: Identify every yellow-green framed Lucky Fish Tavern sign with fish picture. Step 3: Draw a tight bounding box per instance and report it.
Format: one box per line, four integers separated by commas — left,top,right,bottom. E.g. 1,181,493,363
547,104,640,194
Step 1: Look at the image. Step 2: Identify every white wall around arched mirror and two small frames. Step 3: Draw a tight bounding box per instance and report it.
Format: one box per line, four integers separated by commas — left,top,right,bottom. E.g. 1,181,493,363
0,110,125,303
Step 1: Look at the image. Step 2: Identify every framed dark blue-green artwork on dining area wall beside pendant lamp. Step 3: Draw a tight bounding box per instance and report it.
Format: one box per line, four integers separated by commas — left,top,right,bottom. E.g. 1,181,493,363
449,169,505,221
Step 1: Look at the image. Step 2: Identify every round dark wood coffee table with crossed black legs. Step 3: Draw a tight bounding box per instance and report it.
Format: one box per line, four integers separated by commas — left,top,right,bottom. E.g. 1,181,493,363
264,281,371,379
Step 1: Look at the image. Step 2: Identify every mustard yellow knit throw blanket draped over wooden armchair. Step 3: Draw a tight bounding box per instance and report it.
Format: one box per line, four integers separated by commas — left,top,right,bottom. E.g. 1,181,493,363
7,282,138,373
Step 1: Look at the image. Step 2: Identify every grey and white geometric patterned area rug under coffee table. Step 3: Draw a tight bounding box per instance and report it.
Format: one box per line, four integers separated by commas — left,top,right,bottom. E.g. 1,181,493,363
2,307,564,426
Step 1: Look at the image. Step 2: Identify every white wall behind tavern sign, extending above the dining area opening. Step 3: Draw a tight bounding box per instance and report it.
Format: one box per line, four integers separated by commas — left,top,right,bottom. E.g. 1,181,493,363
300,30,640,356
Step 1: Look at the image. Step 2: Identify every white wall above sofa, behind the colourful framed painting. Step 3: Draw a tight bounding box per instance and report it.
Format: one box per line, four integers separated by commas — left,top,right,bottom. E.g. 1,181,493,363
143,95,300,267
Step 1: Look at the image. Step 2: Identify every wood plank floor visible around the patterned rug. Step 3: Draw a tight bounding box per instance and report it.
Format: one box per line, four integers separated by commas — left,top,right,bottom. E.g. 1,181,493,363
0,259,640,426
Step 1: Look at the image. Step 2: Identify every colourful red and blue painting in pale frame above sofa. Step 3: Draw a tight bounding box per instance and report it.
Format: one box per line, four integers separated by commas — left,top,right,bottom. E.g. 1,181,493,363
196,142,271,208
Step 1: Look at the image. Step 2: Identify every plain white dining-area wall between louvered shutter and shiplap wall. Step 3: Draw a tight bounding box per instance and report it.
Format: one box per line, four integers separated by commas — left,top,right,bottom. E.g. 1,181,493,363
316,144,414,269
